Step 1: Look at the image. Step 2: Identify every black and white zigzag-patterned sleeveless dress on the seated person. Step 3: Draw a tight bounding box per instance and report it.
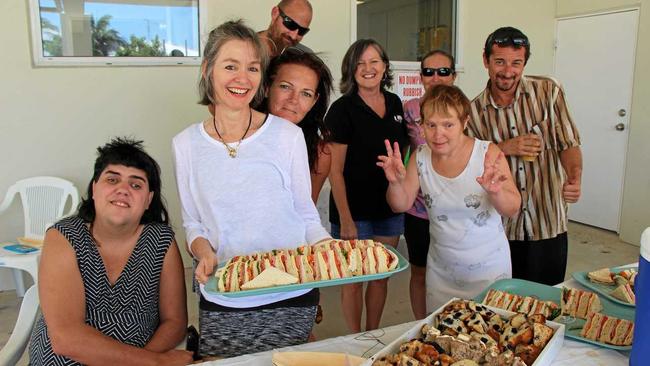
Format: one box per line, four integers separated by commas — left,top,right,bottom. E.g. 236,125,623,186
29,216,174,365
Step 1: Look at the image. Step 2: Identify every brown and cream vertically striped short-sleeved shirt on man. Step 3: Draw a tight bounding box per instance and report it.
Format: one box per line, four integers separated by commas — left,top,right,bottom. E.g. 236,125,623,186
468,76,580,240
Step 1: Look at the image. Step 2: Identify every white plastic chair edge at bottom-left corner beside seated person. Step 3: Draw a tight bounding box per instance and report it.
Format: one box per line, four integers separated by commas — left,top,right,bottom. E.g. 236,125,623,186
0,285,39,365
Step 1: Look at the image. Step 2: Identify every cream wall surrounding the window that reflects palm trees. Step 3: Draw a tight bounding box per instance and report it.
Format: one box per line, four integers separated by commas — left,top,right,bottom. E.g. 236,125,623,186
0,0,351,288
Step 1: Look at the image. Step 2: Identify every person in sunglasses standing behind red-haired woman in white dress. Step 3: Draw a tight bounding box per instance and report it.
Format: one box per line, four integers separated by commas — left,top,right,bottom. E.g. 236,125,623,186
404,50,456,319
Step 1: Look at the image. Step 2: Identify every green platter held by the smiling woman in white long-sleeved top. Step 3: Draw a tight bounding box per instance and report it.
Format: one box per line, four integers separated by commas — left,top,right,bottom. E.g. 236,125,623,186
204,245,409,297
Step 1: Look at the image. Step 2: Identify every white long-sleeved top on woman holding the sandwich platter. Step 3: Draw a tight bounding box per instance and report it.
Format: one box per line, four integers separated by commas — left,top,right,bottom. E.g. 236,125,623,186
172,114,330,308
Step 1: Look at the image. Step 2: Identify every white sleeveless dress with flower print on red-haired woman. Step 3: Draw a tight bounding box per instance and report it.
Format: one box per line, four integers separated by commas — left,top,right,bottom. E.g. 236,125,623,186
417,139,512,312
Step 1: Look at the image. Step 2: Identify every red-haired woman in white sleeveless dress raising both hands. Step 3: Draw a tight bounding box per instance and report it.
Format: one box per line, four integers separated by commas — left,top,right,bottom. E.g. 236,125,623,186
377,85,521,312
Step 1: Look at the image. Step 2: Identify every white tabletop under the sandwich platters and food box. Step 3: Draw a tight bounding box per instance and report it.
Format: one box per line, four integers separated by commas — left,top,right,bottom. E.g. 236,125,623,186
200,279,629,366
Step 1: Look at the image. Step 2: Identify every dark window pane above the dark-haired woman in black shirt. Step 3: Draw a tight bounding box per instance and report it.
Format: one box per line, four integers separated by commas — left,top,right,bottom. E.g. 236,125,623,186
357,0,457,62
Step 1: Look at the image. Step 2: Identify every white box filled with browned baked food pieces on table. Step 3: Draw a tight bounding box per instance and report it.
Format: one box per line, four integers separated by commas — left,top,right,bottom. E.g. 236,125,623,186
362,298,565,366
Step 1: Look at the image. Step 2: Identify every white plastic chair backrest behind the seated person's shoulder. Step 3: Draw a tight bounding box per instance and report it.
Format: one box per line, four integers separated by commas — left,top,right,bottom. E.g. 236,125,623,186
0,177,79,240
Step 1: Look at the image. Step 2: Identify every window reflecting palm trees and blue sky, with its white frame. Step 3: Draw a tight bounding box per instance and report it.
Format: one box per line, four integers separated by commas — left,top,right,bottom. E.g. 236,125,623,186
30,0,201,66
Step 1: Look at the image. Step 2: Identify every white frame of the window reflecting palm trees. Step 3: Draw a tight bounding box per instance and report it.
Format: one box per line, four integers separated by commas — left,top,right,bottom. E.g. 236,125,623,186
28,0,208,67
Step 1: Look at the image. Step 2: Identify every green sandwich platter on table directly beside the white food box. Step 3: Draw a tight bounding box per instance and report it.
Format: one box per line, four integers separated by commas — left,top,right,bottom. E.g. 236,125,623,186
474,278,634,351
